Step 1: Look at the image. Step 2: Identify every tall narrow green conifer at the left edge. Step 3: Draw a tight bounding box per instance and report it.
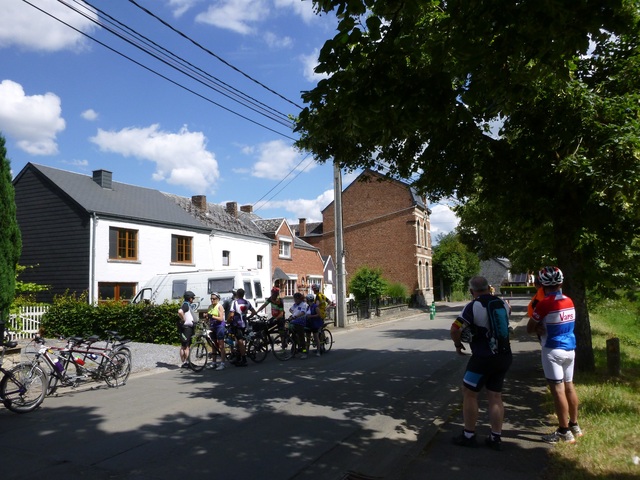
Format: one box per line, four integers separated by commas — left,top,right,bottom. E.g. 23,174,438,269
0,135,22,321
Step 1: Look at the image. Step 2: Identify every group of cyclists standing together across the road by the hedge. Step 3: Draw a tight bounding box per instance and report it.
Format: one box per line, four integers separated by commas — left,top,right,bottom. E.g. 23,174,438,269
178,284,328,370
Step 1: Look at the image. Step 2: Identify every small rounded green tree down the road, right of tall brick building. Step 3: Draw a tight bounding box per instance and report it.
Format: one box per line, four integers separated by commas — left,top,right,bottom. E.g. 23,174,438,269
433,232,480,294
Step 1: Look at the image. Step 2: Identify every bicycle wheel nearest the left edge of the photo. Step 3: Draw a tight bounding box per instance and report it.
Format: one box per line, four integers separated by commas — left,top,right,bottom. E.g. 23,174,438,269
0,363,47,413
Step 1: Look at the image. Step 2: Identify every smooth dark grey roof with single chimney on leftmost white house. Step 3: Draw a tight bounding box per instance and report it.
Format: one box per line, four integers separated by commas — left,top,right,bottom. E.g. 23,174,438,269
14,163,208,230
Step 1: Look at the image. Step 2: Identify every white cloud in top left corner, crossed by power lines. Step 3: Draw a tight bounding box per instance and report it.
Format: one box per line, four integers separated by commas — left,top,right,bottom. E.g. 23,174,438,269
0,0,97,52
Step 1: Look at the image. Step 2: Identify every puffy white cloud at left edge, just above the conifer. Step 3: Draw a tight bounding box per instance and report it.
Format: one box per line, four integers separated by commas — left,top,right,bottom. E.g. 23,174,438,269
0,80,66,155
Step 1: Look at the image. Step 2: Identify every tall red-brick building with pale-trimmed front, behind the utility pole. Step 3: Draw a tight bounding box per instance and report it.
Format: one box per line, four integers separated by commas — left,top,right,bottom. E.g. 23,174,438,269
295,171,433,305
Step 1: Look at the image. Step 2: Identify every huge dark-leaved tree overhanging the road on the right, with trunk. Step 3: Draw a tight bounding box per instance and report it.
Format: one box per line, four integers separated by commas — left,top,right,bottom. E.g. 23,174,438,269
297,0,640,370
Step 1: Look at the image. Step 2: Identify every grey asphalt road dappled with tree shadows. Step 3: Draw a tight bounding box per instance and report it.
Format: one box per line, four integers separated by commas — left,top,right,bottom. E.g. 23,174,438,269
0,305,528,480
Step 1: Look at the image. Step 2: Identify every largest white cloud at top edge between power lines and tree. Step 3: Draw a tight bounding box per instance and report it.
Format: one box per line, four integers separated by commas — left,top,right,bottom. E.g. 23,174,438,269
196,0,269,35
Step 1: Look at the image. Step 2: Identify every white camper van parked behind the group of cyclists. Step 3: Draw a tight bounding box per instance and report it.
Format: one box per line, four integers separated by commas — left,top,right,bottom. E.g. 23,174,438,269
132,270,264,313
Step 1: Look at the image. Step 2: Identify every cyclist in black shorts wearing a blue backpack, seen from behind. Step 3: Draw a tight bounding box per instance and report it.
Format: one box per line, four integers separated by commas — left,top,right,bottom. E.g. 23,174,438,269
451,276,513,450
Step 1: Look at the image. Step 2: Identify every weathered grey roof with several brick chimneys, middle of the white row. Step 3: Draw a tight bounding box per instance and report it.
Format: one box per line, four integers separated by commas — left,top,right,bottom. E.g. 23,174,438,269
163,193,265,240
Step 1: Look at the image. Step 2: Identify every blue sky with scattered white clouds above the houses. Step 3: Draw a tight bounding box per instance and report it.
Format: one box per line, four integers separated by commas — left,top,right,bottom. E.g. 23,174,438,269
0,0,457,236
